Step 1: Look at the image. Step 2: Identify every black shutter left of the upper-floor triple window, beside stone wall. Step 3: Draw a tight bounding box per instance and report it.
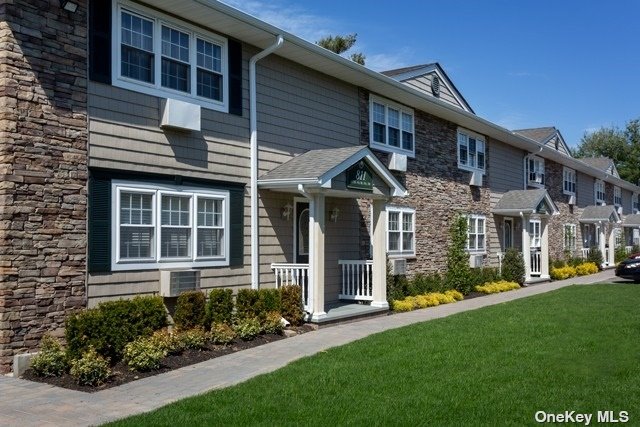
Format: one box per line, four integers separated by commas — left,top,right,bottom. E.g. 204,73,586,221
89,0,111,84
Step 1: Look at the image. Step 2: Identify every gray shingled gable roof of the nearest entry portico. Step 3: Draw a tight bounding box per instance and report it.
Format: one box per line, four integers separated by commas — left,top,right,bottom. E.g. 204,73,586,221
258,145,408,197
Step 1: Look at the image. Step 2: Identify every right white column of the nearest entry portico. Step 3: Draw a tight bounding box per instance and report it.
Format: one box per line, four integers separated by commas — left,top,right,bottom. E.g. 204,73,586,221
371,200,389,308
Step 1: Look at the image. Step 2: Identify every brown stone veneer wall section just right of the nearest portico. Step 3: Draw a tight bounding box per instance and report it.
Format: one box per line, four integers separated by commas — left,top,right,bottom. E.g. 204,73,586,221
359,89,492,275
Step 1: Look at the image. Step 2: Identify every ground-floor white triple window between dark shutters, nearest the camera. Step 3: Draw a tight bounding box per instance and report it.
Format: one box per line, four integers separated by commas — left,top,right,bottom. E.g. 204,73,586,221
112,181,229,270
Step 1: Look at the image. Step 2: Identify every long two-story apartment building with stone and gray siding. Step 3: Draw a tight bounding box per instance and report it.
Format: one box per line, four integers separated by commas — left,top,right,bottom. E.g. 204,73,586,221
0,0,640,372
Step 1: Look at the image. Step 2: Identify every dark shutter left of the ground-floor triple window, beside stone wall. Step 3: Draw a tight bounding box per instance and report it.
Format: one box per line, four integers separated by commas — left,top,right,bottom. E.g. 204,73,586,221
88,176,111,273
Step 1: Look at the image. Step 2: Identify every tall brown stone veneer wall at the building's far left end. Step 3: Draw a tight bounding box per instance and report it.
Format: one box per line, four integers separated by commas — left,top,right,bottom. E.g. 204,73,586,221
0,0,87,372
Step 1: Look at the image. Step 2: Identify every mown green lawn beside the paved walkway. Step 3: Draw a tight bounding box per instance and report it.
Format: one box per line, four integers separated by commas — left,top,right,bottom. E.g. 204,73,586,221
109,285,640,426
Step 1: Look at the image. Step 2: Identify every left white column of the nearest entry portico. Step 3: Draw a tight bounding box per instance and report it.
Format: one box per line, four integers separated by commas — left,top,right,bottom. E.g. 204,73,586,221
309,194,327,321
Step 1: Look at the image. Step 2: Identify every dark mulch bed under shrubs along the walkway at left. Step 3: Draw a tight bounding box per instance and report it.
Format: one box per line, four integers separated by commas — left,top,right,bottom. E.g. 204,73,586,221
21,325,314,393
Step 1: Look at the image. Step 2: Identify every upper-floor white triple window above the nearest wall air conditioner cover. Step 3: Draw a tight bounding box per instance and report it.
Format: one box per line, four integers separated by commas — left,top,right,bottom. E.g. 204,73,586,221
112,0,228,112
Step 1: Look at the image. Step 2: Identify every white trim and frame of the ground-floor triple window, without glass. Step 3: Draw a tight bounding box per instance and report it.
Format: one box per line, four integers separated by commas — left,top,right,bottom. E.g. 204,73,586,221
111,180,231,271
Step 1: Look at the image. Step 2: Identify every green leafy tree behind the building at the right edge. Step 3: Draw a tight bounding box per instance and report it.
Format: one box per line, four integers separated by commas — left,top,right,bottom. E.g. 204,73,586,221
573,119,640,184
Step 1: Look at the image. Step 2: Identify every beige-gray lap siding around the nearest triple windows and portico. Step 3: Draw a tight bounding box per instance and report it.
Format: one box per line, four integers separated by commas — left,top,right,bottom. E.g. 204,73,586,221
88,45,360,306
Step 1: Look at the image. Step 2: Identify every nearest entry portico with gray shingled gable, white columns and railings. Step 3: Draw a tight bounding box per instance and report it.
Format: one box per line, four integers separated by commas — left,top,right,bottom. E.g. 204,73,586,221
258,146,407,322
